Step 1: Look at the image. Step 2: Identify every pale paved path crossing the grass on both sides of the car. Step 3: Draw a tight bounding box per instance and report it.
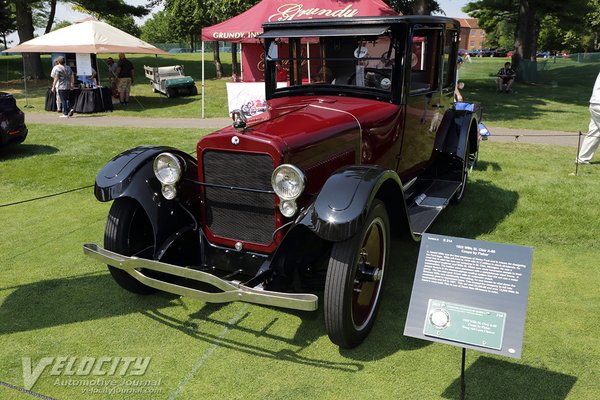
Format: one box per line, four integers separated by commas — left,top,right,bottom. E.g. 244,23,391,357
25,112,579,147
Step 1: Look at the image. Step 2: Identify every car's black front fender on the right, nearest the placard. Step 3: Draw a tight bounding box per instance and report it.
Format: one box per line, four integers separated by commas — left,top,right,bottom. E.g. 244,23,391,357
297,166,402,242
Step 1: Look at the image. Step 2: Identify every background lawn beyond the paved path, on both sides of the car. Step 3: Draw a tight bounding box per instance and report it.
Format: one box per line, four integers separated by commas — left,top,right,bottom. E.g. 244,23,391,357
0,53,598,132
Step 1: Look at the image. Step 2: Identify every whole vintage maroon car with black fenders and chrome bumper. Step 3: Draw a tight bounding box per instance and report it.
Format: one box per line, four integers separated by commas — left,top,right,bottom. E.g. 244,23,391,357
84,16,481,347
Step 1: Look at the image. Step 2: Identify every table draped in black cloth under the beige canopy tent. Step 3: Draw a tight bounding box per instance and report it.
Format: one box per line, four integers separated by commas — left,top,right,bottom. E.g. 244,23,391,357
45,87,113,114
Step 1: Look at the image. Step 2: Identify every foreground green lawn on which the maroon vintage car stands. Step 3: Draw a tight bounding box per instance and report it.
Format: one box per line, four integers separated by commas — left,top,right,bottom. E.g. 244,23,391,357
0,124,600,400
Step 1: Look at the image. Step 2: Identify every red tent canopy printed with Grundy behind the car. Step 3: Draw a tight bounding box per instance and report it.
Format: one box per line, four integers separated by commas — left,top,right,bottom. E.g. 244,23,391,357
202,0,398,43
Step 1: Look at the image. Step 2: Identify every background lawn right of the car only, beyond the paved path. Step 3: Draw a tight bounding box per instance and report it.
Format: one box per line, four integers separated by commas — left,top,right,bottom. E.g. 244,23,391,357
460,58,598,132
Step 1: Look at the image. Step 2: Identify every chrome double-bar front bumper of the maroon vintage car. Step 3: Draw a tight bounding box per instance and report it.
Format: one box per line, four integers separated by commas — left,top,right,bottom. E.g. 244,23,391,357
83,243,318,311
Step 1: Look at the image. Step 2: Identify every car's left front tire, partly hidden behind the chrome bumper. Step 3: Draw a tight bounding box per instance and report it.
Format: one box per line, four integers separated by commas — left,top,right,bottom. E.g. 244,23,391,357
104,197,156,294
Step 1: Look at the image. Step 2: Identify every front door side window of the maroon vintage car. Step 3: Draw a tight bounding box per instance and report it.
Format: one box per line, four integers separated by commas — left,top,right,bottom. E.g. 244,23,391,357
410,29,442,93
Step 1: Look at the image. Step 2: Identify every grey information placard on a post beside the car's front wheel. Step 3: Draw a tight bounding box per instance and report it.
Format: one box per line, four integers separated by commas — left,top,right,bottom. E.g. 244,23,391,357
404,234,533,358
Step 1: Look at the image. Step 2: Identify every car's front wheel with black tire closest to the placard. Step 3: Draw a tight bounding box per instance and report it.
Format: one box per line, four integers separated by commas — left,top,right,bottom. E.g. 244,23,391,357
324,200,390,348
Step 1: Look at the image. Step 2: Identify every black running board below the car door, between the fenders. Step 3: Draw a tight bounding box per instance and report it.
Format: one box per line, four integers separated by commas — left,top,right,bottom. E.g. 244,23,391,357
408,180,460,235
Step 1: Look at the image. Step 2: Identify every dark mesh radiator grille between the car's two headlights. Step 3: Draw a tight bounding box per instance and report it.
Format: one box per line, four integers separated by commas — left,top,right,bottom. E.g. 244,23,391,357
202,150,275,245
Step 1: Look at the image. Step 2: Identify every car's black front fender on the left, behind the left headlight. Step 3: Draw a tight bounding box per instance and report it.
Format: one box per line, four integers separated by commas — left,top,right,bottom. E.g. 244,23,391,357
94,146,200,259
